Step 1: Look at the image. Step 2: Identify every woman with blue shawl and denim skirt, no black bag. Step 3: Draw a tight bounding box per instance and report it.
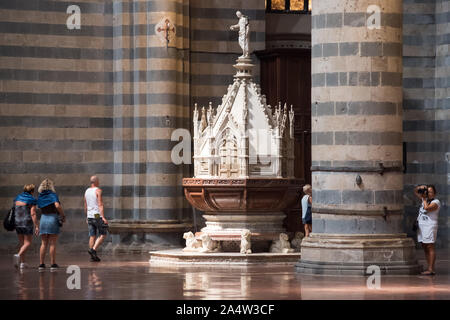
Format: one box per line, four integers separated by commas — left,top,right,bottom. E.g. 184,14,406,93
37,179,66,271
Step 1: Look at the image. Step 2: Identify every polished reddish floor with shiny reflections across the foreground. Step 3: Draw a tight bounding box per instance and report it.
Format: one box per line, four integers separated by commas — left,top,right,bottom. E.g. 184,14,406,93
0,250,450,300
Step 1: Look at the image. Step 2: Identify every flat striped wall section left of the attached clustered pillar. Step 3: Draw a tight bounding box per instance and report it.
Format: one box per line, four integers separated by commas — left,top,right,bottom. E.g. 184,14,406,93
0,0,114,249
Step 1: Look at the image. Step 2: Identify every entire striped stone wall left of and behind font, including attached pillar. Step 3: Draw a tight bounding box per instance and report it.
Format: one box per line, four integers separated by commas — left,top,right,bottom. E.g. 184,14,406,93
0,0,265,248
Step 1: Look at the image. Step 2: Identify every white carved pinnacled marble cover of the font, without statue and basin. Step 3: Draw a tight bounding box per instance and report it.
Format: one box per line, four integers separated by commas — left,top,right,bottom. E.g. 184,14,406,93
194,57,294,178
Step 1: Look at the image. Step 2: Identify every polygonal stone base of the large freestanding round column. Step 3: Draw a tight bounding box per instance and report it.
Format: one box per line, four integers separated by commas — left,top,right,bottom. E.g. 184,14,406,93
295,233,421,275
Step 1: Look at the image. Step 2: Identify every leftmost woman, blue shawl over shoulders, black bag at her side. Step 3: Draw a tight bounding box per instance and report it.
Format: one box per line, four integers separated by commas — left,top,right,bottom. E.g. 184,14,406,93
13,184,39,269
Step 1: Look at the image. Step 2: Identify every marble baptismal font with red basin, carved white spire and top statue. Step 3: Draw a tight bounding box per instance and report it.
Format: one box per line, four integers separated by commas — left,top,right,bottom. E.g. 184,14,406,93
183,11,304,253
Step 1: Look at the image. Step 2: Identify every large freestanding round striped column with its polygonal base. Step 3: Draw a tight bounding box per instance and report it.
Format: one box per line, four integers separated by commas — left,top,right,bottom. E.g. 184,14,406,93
296,0,418,274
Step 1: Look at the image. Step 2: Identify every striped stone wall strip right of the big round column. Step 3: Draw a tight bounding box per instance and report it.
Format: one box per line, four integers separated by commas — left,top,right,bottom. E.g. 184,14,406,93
403,0,450,247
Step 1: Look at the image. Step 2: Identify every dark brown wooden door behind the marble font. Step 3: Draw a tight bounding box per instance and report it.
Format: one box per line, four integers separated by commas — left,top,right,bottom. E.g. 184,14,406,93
256,49,311,232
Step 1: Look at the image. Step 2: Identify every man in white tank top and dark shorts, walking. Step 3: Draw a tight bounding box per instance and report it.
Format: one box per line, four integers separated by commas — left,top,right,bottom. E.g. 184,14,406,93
84,176,108,262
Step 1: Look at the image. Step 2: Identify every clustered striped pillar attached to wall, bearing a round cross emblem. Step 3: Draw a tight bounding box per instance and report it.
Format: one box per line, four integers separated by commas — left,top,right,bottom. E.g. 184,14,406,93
112,0,192,248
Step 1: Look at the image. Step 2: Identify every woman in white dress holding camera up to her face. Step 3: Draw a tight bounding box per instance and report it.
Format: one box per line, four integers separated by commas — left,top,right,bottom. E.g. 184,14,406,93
414,185,441,275
